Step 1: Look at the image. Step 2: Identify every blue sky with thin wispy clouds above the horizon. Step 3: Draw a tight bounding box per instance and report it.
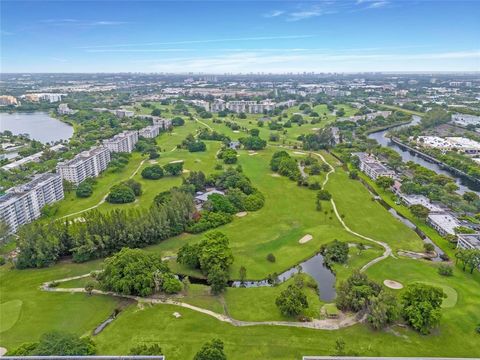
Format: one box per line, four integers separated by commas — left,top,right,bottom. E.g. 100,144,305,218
0,0,480,73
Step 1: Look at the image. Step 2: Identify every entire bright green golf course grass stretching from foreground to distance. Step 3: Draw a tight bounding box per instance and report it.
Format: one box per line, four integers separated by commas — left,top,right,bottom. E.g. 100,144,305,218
0,105,480,360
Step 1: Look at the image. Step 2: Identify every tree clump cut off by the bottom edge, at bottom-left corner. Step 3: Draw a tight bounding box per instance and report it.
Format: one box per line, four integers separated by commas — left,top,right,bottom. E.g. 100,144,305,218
9,331,95,356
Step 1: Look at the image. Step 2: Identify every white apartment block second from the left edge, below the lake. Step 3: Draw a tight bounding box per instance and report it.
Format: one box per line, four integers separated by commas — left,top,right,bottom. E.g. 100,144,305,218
57,146,110,185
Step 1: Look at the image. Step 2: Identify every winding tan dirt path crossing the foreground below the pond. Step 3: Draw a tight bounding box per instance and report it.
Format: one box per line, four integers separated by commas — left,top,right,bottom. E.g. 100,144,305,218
41,282,364,330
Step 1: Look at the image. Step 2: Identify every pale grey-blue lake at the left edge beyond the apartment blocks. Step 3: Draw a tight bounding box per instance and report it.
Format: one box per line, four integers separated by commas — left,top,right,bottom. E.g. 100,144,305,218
0,112,73,144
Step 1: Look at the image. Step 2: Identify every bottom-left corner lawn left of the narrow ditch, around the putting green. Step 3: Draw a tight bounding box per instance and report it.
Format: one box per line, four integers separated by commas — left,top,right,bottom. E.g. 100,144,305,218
0,261,118,349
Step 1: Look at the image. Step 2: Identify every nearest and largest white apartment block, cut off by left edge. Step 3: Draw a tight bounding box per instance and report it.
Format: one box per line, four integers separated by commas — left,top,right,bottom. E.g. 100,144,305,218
0,173,64,232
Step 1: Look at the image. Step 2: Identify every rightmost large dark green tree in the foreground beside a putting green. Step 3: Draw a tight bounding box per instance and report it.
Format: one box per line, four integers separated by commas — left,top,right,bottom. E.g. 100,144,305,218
402,283,446,334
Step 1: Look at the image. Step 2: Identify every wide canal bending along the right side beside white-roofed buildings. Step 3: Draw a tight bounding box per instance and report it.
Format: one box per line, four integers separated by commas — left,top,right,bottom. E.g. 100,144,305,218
368,115,480,194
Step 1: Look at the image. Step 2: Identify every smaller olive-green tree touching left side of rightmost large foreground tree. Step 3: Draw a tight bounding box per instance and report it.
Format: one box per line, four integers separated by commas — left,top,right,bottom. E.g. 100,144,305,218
367,291,399,330
